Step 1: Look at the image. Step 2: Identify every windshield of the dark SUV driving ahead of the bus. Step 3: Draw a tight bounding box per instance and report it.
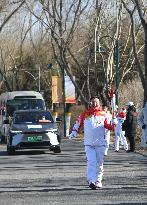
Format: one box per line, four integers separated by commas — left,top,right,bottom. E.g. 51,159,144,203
13,112,53,124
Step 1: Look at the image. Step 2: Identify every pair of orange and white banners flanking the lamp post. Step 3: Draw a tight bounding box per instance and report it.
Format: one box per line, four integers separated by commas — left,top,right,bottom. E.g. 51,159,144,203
52,76,76,104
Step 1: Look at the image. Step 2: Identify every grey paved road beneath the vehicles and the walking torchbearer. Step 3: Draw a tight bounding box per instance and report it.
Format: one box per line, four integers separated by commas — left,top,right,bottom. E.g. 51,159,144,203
0,139,147,205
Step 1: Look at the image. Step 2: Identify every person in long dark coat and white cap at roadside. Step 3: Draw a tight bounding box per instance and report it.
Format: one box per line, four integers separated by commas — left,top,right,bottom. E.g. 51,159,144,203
123,102,137,152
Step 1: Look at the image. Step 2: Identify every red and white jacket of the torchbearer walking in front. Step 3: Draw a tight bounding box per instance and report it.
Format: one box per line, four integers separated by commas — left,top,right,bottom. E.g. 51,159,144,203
69,108,113,146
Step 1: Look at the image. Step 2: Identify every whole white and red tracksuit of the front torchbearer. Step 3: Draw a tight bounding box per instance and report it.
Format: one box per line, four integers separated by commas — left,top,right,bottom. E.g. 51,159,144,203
70,107,113,184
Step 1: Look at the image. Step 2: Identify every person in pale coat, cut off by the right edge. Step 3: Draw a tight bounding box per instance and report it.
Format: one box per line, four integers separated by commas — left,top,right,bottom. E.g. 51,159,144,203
137,102,147,148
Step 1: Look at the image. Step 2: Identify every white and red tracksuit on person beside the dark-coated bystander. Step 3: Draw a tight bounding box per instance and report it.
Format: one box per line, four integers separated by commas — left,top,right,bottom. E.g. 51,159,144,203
115,110,128,151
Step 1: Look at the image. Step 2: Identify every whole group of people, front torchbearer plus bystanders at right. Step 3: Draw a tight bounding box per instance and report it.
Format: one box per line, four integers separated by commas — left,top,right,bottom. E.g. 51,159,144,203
69,97,147,189
